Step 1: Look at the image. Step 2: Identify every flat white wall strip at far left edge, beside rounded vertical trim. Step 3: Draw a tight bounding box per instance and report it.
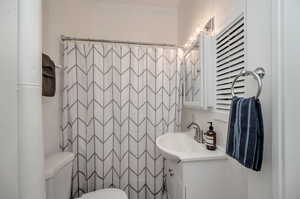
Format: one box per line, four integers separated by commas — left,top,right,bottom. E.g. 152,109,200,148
0,0,19,199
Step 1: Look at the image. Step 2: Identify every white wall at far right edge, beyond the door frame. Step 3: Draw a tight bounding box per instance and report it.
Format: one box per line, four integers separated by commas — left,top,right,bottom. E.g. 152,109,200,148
276,0,300,199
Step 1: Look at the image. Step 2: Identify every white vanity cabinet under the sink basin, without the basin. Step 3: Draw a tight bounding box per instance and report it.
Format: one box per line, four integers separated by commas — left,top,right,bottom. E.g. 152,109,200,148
166,158,231,199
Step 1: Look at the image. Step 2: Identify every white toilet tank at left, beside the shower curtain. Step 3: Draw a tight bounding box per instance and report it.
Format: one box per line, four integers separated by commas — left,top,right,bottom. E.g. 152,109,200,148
45,152,74,199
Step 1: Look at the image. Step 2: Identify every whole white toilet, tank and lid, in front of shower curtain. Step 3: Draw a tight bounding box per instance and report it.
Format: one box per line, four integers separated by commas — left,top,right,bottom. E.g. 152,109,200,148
45,152,128,199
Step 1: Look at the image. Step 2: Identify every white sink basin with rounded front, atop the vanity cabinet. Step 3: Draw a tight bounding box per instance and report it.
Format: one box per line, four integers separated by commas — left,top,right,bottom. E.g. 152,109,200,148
156,132,226,162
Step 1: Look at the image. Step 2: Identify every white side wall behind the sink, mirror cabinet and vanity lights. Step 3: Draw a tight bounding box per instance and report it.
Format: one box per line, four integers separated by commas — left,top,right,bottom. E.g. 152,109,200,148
178,0,248,199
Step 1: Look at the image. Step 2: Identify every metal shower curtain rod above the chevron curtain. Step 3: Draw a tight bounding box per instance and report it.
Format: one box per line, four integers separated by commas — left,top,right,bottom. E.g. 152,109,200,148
61,35,181,48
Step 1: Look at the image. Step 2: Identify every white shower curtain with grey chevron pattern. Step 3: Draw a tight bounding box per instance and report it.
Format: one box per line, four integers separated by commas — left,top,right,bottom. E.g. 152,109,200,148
60,41,182,199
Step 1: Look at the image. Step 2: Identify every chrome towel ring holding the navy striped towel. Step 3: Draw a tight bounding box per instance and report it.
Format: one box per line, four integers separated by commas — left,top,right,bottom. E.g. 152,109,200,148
231,67,265,99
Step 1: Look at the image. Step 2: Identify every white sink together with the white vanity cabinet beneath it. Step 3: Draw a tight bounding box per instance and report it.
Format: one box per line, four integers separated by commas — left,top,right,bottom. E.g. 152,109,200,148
156,132,231,199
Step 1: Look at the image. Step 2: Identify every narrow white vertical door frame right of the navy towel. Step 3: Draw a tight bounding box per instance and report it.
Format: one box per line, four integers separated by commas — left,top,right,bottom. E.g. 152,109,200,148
272,0,285,199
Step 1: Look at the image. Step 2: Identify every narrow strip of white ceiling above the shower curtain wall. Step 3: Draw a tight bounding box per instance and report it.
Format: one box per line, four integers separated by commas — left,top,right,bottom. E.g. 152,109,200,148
99,0,181,8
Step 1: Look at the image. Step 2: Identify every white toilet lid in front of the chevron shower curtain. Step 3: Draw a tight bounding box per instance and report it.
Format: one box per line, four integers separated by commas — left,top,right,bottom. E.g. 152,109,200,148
80,189,127,199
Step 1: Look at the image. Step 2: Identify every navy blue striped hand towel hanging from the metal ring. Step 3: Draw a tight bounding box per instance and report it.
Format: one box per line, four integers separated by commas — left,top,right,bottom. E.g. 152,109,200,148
226,97,264,171
